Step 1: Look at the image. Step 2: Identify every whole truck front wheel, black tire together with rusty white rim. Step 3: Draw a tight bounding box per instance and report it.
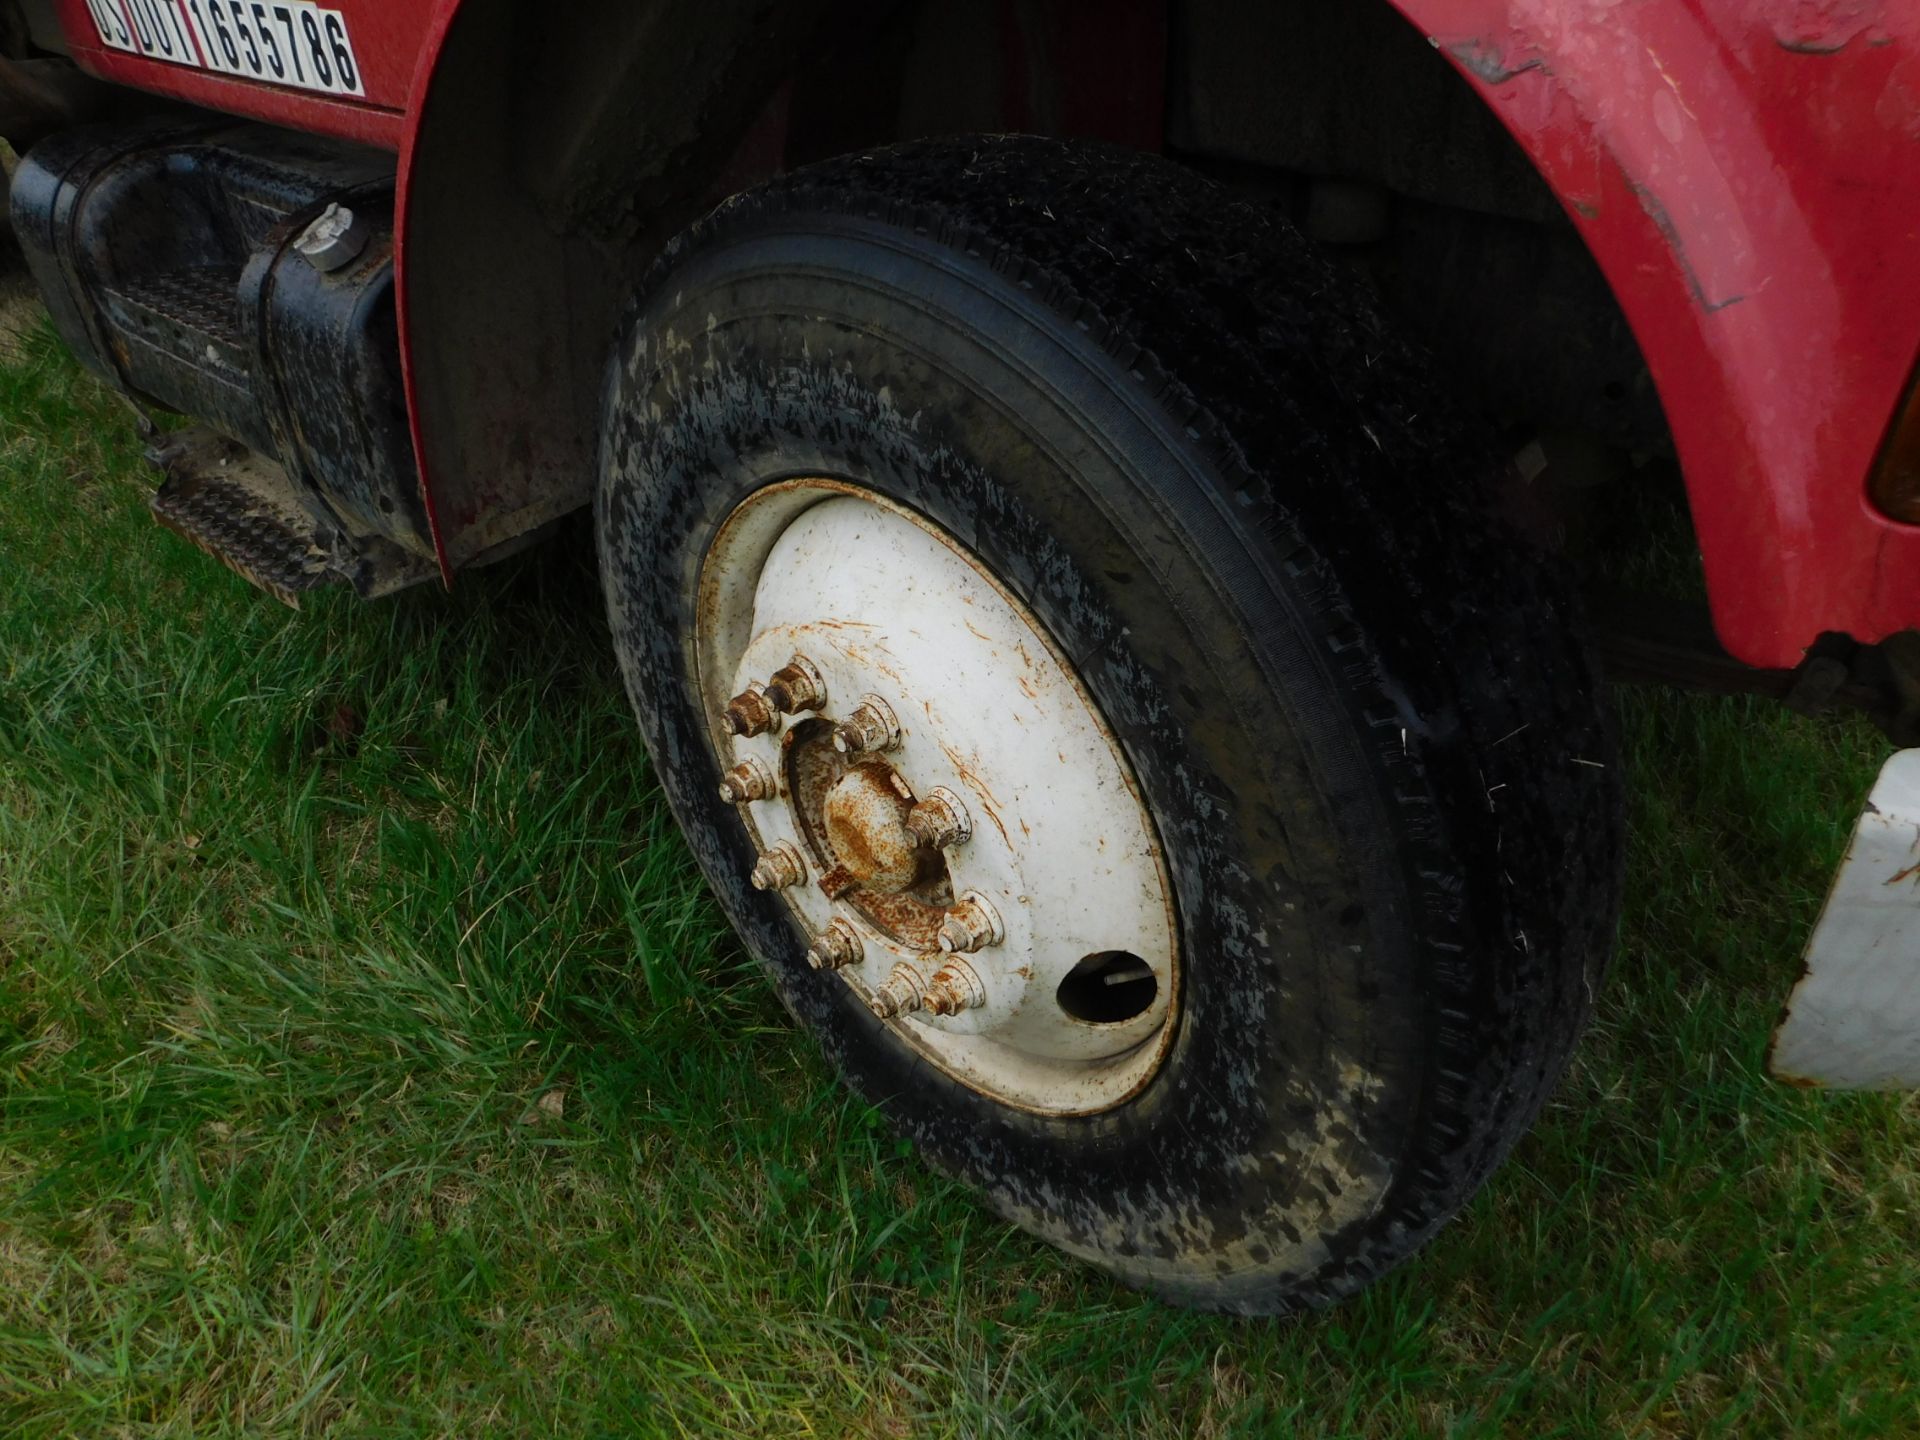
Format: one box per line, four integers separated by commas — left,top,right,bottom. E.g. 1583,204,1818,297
597,140,1620,1311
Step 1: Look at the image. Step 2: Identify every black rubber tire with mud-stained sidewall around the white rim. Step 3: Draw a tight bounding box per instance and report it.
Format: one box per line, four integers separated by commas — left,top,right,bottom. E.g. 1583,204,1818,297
597,140,1620,1311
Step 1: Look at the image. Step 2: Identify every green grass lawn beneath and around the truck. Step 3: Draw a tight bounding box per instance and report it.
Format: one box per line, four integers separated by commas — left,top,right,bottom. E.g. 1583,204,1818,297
0,314,1920,1440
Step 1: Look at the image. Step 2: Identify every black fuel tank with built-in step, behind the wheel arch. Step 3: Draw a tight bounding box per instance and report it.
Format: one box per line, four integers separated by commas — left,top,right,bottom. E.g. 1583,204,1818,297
12,119,432,555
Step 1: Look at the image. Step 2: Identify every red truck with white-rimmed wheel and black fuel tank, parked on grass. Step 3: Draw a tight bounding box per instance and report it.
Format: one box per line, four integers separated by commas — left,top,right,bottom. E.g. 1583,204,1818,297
0,0,1920,1311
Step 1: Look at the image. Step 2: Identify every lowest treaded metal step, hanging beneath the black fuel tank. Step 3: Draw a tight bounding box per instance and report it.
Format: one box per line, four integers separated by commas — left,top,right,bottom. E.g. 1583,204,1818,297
148,428,438,611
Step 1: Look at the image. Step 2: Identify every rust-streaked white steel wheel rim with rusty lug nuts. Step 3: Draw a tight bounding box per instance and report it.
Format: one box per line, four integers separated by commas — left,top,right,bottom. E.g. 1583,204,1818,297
695,480,1179,1116
